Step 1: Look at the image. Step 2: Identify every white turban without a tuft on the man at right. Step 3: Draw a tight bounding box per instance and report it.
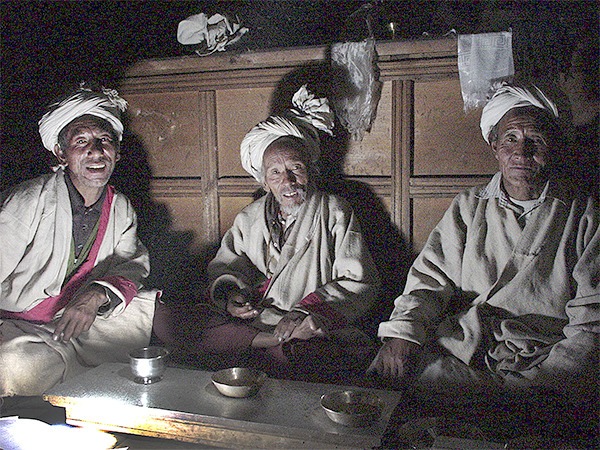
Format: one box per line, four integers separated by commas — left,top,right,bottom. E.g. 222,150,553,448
480,85,558,144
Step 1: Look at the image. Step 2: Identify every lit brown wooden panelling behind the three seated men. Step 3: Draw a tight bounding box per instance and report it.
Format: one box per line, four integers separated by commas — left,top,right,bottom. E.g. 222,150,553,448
120,39,490,264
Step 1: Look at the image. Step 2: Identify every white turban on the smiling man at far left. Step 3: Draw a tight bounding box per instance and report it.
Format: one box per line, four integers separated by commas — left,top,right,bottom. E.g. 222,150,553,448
38,87,127,153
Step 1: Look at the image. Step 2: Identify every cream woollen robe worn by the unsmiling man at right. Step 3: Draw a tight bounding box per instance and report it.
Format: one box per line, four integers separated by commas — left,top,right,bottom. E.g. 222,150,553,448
378,173,600,389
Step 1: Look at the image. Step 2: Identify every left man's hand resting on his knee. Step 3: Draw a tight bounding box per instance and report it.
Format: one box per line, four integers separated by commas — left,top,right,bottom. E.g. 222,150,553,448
52,284,107,342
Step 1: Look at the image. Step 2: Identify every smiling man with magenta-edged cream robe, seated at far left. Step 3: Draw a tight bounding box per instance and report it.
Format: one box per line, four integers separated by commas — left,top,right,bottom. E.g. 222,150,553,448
0,87,156,396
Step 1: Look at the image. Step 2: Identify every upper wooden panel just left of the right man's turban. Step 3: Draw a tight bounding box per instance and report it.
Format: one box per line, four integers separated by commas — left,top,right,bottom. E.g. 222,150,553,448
413,77,498,175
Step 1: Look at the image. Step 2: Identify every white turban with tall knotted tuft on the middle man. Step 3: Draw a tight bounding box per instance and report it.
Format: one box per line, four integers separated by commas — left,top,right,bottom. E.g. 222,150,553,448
240,85,333,182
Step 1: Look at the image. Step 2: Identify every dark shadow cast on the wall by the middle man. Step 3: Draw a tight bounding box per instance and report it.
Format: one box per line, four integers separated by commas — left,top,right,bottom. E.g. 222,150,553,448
271,62,415,336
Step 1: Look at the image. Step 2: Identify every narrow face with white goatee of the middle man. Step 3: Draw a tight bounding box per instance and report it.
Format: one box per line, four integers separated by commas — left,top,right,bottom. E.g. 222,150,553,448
263,138,309,215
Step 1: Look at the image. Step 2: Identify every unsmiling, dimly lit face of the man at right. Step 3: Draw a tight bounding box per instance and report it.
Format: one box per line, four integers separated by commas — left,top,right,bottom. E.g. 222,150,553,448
491,108,551,200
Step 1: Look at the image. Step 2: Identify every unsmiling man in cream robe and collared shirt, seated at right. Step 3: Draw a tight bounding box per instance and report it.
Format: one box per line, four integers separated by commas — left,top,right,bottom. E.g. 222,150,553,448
370,85,600,393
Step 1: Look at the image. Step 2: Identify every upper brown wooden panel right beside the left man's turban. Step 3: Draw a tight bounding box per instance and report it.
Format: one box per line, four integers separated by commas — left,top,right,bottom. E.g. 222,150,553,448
126,91,201,177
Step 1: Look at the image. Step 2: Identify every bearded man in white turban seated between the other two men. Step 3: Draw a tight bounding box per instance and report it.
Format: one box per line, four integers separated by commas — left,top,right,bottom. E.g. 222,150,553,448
169,86,378,379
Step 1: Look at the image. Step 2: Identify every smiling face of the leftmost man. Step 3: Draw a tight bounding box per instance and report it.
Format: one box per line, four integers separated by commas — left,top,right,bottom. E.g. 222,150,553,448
55,115,121,192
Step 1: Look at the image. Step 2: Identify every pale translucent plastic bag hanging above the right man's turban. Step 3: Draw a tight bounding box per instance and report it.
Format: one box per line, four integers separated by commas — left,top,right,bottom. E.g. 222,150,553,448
458,31,515,112
